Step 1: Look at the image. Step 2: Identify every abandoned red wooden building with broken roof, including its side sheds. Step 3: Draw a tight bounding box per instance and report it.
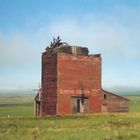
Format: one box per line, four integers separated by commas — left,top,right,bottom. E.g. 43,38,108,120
35,37,129,116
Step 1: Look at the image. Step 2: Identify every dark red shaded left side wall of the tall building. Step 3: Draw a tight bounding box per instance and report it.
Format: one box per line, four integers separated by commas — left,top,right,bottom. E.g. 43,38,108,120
40,53,57,116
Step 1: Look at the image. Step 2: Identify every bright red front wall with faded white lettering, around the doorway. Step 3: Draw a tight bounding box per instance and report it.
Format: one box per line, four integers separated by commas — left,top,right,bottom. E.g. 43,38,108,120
57,53,101,114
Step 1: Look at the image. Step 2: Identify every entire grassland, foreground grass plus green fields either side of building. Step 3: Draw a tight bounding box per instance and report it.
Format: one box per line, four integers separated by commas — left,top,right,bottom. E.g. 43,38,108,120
0,96,140,140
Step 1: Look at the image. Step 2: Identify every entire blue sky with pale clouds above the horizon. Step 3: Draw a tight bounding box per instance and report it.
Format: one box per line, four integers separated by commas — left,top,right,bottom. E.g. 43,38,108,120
0,0,140,90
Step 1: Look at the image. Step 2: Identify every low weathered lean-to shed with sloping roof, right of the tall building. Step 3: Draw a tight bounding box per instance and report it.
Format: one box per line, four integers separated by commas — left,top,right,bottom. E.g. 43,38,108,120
101,90,129,112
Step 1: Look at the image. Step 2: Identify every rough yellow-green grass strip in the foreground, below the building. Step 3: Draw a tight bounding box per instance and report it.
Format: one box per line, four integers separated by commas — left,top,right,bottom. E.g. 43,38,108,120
0,113,140,140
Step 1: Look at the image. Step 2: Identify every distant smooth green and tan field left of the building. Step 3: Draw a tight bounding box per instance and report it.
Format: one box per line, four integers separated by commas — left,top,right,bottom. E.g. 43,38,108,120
0,96,34,117
